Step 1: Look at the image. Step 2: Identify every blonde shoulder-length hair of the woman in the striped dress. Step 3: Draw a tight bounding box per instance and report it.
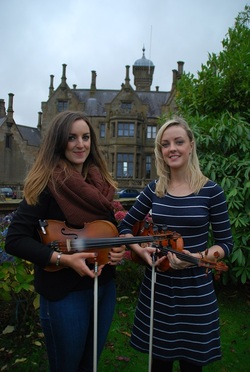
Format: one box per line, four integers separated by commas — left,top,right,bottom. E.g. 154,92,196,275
155,117,208,197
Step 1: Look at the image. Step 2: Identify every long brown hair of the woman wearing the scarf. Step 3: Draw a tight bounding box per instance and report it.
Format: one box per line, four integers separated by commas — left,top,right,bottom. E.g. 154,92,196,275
24,111,116,205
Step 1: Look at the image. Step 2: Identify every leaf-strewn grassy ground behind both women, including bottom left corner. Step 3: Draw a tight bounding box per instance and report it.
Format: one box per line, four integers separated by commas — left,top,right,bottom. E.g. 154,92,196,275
0,289,250,372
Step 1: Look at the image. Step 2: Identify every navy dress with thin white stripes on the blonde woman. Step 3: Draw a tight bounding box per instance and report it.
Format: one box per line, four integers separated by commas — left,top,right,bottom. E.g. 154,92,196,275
119,181,233,366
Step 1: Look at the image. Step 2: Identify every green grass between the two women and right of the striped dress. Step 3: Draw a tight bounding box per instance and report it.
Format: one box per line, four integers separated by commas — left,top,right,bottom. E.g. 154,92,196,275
98,289,250,372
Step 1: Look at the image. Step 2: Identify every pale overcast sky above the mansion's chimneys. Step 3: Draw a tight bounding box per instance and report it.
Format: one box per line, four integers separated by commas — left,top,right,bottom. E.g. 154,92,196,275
0,0,246,127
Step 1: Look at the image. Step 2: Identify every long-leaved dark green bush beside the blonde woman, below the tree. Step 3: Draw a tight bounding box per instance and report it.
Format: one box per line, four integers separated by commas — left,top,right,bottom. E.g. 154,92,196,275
172,113,250,284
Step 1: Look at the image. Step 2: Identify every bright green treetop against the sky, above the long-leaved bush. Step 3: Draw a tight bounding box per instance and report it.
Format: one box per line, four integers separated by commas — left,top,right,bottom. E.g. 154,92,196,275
176,5,250,118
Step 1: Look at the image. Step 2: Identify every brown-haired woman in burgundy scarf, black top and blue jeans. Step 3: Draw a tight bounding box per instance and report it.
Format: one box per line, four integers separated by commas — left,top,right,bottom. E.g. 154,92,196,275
5,111,124,372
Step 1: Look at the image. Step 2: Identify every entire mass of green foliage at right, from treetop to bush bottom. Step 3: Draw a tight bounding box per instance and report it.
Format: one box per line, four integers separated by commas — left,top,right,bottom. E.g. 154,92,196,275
173,6,250,283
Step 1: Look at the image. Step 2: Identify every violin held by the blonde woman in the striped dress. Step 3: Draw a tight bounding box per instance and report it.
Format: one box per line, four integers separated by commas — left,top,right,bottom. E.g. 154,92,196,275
131,220,228,279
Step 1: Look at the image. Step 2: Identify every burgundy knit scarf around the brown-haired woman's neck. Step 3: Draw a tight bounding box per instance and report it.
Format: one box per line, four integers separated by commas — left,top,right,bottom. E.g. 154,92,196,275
49,166,115,227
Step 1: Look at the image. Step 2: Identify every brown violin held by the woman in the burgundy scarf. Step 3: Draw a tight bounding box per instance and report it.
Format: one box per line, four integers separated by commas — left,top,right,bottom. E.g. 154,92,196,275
38,220,178,271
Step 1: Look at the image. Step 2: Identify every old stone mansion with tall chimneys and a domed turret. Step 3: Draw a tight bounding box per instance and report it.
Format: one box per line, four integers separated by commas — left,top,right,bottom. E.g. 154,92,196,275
0,49,183,190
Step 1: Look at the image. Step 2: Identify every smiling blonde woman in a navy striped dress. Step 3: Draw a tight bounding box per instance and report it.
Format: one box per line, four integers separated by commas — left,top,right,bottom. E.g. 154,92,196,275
119,118,233,372
